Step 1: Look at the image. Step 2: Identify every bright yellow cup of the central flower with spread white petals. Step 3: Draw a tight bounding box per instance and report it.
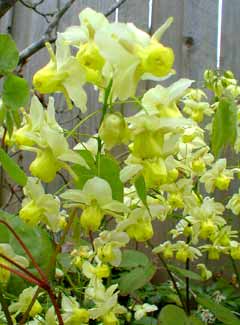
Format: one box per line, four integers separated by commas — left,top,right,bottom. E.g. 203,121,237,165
80,204,104,232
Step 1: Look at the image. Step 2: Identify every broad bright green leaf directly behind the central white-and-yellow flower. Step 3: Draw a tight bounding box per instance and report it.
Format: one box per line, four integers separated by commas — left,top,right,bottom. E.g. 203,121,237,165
73,150,123,202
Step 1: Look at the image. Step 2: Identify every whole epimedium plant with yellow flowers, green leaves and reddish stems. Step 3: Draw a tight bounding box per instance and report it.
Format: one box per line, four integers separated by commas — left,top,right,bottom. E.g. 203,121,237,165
0,8,240,325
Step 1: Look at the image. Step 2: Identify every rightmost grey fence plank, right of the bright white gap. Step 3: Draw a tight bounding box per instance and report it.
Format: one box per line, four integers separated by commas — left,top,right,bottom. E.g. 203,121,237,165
220,0,240,79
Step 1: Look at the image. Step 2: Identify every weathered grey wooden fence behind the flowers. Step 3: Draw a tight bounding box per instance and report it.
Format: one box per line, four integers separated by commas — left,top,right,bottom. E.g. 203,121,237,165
0,0,240,199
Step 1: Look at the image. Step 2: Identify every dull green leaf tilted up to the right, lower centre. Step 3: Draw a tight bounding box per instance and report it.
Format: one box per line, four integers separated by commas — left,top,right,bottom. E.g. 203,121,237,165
117,263,156,295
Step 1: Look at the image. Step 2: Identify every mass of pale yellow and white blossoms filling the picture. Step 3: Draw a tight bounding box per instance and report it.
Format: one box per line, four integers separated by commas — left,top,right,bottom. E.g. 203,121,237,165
0,8,240,325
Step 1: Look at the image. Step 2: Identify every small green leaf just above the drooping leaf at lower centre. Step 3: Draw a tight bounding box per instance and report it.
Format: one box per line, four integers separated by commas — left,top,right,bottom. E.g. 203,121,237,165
119,249,149,269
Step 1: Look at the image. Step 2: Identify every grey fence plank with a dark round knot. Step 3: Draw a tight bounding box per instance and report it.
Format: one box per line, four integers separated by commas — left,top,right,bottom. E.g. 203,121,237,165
182,0,218,85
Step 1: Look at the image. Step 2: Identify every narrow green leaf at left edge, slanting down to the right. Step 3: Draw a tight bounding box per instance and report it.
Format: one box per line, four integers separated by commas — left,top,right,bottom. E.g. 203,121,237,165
0,148,27,186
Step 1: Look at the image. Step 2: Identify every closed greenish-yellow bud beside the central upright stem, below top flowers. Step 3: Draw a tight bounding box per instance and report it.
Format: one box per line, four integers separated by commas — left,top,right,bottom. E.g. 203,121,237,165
99,113,129,150
